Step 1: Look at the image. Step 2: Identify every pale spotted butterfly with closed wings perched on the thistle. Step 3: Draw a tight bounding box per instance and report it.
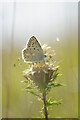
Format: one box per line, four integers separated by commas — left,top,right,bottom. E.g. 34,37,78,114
22,36,45,62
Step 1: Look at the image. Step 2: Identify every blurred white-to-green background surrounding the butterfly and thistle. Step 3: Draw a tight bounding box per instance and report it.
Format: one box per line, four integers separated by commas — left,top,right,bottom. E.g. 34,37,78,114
2,2,78,118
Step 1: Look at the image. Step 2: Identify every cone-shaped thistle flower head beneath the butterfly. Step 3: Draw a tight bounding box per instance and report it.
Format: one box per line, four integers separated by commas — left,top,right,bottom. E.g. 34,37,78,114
24,64,55,91
